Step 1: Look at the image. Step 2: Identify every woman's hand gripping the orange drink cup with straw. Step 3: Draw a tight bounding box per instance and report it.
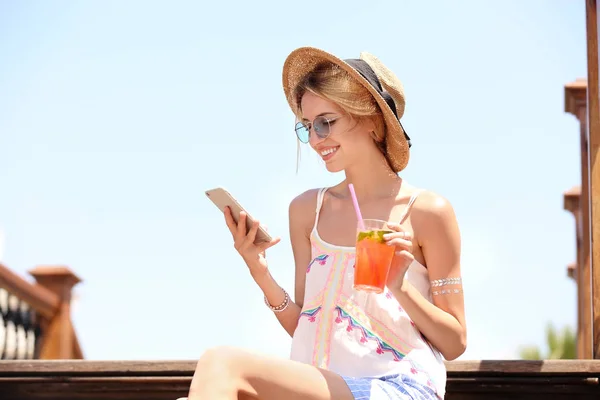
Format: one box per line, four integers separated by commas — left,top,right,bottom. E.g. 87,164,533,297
383,222,415,288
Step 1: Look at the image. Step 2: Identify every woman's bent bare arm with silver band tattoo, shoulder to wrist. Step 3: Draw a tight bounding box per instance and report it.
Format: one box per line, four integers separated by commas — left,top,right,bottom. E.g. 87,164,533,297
389,192,467,360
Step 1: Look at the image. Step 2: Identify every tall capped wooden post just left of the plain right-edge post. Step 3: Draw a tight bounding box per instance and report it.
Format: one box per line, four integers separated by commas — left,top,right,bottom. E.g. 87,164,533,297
565,79,593,359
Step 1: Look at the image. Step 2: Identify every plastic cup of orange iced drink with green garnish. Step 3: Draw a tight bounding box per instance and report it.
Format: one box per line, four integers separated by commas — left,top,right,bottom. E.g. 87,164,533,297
354,219,394,293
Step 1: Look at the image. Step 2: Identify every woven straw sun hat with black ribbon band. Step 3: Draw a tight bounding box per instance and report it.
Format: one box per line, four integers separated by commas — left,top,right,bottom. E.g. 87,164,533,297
283,47,410,172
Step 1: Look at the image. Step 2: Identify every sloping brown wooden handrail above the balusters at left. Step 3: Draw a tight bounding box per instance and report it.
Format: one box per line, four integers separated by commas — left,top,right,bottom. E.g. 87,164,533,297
0,263,60,319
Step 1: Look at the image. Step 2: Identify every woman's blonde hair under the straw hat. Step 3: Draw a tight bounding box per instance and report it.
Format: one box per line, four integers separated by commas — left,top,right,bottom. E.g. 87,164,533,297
293,62,391,168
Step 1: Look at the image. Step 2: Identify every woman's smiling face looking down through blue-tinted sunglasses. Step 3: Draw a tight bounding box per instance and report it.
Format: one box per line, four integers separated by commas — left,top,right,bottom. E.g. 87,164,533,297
300,92,375,172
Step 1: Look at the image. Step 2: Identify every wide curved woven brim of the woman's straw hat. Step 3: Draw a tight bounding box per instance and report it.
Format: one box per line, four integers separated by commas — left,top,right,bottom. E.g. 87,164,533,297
282,47,409,171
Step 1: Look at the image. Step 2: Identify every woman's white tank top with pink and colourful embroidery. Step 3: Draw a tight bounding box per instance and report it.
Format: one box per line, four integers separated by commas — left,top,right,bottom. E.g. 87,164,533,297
291,188,446,398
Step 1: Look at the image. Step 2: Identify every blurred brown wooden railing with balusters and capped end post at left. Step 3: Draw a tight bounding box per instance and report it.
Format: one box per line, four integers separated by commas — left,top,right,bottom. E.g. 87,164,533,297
0,264,83,360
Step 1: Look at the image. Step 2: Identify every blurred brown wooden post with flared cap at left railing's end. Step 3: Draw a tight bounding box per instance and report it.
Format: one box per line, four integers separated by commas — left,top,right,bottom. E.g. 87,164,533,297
29,266,83,360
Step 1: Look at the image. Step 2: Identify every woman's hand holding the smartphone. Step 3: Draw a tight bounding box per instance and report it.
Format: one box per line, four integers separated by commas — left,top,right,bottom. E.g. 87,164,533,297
225,207,281,280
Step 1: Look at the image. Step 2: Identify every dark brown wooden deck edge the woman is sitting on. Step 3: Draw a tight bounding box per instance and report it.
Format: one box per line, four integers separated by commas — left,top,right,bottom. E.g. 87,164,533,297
0,360,600,400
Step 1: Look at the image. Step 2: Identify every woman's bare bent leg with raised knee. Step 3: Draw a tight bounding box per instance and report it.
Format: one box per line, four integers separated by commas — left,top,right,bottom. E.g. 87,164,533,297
180,347,354,400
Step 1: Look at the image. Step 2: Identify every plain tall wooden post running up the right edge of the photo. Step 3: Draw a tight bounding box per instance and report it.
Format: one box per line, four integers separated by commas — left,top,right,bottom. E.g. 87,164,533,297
586,0,600,359
